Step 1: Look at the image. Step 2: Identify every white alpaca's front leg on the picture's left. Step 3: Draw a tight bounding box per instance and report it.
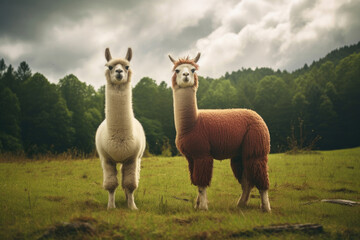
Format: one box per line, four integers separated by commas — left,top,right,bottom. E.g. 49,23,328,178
101,157,119,209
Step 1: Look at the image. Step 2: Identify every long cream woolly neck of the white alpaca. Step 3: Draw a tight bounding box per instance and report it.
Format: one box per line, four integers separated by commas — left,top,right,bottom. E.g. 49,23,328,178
105,83,134,138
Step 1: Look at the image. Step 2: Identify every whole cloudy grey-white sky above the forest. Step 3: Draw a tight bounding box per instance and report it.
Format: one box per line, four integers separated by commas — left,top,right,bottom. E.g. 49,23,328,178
0,0,360,88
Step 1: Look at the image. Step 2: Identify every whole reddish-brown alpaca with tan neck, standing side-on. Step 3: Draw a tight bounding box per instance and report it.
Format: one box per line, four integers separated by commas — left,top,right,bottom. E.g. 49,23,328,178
169,53,271,212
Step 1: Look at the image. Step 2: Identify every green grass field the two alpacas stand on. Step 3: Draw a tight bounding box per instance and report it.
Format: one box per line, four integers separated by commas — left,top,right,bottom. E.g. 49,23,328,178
0,148,360,239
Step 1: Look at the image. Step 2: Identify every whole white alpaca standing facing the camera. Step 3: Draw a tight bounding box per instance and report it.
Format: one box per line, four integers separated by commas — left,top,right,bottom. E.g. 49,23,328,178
96,48,146,210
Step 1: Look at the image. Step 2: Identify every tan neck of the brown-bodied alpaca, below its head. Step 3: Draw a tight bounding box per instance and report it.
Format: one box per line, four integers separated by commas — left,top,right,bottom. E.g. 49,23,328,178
173,87,198,134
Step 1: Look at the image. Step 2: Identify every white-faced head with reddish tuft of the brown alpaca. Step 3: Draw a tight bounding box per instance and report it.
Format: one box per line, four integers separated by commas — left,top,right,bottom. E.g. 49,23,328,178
169,53,200,88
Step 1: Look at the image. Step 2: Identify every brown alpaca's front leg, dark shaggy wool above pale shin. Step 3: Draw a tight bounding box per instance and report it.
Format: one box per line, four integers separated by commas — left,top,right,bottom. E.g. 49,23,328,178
191,157,214,210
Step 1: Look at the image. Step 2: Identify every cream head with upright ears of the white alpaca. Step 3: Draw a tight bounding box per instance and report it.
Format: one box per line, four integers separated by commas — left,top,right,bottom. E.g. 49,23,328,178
105,48,132,85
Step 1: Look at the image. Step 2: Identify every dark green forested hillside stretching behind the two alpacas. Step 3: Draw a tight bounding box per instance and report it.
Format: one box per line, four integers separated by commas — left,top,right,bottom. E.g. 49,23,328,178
0,42,360,156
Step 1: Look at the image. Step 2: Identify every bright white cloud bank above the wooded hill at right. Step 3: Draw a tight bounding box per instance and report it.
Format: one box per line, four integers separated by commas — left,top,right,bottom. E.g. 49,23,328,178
194,0,360,77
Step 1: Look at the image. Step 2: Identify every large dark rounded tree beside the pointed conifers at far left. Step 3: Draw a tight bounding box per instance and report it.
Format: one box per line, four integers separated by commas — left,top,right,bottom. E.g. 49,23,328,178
20,73,73,155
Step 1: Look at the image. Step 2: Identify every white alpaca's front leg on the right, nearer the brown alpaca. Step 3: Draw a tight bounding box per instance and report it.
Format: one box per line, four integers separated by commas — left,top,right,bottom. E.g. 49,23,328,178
121,159,141,210
